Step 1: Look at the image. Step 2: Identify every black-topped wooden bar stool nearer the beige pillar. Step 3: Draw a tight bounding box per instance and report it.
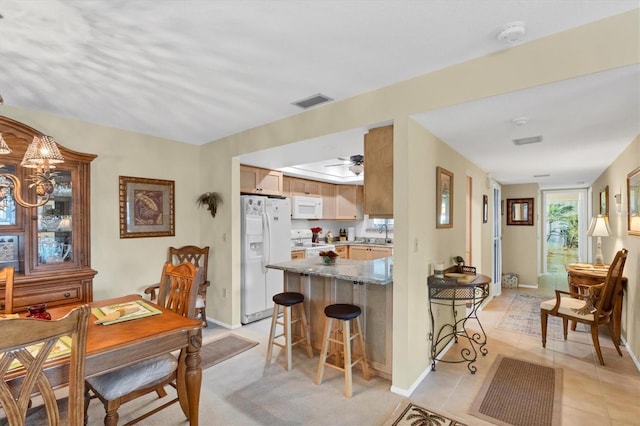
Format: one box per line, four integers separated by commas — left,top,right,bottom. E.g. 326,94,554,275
316,303,370,398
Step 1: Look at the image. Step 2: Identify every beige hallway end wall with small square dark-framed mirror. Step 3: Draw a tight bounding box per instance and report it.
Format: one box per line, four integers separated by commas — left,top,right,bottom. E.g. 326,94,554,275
501,184,542,286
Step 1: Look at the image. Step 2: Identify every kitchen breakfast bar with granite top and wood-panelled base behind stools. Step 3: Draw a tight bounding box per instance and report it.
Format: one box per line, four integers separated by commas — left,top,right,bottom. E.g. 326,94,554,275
267,256,393,380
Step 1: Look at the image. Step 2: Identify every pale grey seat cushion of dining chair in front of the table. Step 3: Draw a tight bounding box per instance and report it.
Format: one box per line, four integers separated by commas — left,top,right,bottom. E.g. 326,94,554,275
87,354,178,401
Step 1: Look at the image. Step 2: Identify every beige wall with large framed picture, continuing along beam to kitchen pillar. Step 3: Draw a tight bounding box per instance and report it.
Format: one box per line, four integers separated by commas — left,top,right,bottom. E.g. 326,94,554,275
3,11,640,393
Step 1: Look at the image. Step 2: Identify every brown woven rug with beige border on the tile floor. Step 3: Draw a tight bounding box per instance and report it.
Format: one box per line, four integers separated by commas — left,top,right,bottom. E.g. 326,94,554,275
469,355,562,426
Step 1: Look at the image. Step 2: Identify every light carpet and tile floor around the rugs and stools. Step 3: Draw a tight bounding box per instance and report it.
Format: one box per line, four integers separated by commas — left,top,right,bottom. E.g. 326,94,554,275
74,275,640,426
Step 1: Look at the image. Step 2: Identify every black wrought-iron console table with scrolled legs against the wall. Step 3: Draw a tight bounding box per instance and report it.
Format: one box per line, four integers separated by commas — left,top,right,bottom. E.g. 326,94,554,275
427,272,491,374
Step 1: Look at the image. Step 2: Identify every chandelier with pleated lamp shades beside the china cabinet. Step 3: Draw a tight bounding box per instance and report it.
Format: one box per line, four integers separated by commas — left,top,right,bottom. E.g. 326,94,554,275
0,133,64,207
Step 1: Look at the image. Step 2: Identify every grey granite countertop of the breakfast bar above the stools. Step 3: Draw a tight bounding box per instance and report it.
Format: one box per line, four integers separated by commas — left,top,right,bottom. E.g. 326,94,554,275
267,256,393,285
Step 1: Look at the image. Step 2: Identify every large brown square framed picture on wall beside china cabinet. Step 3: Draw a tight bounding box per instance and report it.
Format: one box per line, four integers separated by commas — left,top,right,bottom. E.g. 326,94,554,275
119,176,175,238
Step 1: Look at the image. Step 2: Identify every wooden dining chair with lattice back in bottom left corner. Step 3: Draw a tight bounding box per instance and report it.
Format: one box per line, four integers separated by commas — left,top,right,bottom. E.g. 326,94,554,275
0,305,91,426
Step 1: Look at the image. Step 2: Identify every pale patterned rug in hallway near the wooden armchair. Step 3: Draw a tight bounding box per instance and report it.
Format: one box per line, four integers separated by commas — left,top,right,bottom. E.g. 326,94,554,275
496,293,568,340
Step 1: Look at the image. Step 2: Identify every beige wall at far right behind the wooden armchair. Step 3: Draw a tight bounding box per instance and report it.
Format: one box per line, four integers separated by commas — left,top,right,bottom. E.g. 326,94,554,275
592,135,640,357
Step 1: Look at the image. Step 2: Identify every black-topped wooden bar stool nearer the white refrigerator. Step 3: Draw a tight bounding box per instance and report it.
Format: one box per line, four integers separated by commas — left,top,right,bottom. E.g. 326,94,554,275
267,292,313,370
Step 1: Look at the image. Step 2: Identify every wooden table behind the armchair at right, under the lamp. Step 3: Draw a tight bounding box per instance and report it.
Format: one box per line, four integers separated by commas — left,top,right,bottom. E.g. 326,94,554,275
565,263,628,343
